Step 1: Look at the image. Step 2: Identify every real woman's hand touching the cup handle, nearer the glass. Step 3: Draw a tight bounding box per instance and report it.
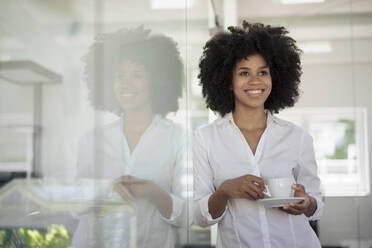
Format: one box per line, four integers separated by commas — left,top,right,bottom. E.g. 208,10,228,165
218,174,266,201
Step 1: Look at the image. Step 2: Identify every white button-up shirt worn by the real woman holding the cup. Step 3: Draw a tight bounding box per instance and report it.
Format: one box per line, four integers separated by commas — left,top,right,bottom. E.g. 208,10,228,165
193,113,323,248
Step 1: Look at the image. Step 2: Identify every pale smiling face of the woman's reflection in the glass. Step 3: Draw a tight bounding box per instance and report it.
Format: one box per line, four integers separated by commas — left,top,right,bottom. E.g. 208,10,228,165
114,60,150,110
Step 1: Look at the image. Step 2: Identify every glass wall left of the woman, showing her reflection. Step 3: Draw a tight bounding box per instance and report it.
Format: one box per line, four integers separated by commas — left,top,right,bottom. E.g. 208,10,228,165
0,0,198,247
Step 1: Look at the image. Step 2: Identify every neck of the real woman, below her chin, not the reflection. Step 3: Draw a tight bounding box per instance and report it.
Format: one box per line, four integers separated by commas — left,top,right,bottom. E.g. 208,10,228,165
233,105,267,130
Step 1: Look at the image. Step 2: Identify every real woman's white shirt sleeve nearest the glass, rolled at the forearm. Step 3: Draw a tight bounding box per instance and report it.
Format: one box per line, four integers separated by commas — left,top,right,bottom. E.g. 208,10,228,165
193,130,227,227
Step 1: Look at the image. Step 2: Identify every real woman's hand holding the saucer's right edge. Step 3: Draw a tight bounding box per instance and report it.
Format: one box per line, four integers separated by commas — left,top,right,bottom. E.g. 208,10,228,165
282,184,316,216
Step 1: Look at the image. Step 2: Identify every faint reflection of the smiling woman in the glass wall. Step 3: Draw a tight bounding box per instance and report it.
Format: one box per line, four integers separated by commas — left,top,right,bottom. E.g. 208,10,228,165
74,28,184,247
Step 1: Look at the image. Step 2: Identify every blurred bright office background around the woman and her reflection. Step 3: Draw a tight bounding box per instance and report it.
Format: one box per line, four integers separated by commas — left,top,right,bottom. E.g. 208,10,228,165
0,0,372,248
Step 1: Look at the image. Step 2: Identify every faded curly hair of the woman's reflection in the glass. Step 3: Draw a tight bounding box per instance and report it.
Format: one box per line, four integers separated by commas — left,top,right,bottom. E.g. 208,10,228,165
83,27,184,116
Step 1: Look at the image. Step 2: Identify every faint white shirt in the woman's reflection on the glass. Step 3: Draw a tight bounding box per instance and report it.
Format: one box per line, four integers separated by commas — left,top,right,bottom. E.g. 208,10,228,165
74,115,185,248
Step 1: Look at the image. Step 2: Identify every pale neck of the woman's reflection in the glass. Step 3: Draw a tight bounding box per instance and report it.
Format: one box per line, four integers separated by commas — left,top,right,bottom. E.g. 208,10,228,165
123,107,155,132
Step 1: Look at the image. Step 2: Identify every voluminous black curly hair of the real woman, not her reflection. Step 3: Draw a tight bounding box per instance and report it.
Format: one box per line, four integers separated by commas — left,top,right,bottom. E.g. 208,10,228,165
198,21,302,116
